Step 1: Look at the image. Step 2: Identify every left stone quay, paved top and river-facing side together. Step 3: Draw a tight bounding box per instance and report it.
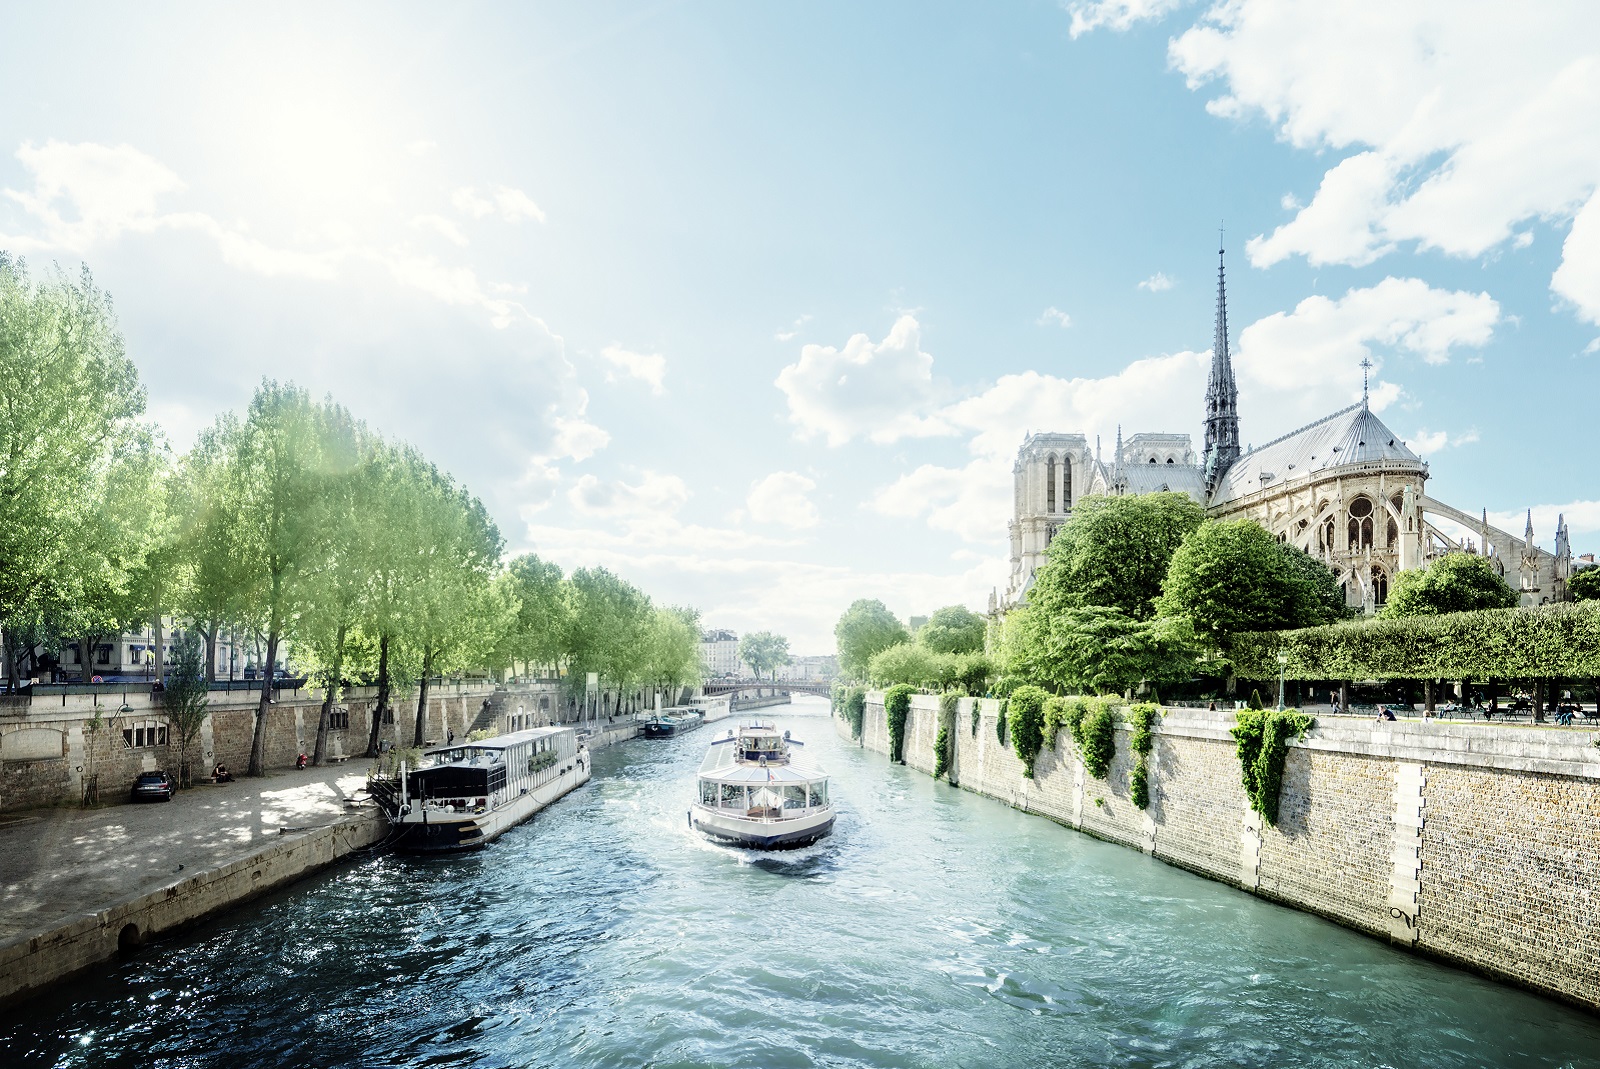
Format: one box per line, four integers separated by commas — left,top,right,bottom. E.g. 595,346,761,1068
0,760,389,1003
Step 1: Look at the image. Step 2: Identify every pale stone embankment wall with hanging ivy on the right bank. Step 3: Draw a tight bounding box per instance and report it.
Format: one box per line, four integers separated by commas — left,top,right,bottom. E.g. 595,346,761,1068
835,693,1600,1008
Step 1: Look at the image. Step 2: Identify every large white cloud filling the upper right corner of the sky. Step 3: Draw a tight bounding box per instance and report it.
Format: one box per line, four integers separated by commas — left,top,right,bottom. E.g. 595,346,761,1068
1158,0,1600,322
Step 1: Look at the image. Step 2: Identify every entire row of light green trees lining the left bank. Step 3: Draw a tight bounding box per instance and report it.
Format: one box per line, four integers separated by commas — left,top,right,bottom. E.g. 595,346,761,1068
0,254,699,775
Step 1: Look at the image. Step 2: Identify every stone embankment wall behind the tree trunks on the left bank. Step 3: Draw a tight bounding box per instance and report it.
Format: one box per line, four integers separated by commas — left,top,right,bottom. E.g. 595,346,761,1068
0,683,566,811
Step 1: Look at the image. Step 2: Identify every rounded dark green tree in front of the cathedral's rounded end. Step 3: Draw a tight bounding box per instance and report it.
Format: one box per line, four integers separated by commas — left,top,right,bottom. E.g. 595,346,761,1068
1158,520,1344,645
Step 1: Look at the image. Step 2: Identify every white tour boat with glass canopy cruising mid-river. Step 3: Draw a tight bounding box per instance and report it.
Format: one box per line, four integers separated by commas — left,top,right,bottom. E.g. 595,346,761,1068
690,723,834,850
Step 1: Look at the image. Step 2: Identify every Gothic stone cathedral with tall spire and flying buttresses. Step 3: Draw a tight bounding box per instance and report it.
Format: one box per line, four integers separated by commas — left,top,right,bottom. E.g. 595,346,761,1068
1002,251,1573,615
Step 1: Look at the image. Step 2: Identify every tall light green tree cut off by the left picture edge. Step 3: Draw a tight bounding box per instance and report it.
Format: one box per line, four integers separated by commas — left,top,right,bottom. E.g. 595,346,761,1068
0,253,146,685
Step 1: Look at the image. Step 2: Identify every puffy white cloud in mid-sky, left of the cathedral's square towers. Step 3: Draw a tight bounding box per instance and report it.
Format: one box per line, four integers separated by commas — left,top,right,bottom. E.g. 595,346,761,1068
776,315,939,445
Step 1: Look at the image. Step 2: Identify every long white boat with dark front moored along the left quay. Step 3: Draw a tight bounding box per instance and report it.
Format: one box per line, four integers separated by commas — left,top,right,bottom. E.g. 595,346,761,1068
387,727,589,853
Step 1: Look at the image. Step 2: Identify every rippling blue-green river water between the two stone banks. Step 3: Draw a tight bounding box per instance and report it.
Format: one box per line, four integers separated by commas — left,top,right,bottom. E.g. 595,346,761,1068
0,699,1600,1069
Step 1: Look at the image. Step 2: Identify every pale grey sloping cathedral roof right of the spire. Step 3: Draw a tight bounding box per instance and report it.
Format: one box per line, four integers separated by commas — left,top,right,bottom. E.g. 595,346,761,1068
1211,405,1422,506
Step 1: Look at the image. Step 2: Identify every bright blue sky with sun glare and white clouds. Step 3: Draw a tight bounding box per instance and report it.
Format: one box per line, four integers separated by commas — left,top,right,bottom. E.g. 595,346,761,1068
0,0,1600,653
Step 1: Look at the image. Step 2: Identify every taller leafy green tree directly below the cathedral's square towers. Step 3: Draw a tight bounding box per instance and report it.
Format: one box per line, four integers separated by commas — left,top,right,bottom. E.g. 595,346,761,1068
1027,493,1205,619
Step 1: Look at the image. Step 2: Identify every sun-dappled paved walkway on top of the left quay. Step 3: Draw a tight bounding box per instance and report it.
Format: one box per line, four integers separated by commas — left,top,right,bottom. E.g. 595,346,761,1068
0,759,371,943
